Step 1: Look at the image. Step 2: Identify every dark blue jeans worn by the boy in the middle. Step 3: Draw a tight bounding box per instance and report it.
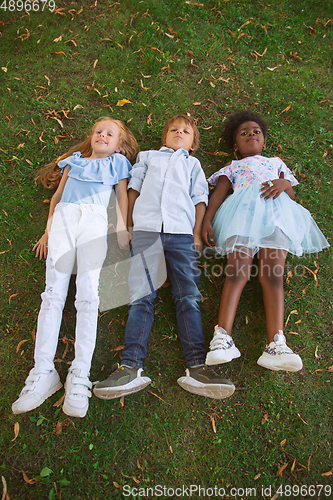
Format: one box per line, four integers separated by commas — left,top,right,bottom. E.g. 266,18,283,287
121,231,206,368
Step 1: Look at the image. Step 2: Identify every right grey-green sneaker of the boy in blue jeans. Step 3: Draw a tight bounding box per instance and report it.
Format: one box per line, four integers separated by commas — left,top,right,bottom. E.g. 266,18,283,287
177,365,235,399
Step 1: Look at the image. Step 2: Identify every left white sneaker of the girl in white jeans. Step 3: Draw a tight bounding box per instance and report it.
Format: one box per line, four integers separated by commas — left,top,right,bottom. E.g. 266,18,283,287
12,368,62,415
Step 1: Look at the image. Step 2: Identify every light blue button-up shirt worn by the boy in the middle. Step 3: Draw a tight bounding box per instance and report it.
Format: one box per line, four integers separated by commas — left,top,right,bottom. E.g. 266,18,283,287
128,146,208,234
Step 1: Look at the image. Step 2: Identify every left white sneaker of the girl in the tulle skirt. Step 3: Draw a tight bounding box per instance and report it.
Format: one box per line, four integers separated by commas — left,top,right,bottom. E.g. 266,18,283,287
206,325,241,365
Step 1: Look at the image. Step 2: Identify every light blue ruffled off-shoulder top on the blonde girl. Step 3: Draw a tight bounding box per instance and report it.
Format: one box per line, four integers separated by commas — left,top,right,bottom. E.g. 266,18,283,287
58,151,132,207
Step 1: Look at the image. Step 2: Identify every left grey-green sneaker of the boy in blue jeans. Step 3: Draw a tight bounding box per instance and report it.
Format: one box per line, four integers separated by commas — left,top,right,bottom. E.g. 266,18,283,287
93,364,151,399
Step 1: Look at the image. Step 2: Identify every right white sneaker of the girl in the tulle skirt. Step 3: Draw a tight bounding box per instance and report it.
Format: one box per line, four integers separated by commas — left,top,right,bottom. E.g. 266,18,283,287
257,330,303,372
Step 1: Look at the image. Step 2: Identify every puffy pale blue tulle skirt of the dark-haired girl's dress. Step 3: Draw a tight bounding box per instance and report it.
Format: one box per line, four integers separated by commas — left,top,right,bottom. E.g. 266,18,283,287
212,184,329,256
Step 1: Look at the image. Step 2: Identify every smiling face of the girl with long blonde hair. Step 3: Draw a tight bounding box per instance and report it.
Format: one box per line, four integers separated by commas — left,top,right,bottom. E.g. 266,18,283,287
90,120,120,158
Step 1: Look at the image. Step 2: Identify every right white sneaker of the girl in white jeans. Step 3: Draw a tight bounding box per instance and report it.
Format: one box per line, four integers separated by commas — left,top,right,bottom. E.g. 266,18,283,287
62,368,92,418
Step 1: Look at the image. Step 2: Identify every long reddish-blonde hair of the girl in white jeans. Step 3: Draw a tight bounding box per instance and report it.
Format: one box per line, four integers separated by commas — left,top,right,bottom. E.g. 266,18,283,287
35,116,140,189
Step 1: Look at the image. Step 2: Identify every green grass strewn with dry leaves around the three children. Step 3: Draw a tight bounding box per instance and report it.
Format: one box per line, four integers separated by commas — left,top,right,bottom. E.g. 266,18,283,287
0,0,333,500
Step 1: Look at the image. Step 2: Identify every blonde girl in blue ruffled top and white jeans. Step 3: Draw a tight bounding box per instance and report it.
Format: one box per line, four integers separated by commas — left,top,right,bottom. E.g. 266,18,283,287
12,117,139,417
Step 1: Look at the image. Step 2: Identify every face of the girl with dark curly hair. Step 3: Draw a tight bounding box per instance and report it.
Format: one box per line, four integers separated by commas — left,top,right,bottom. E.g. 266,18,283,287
234,122,265,158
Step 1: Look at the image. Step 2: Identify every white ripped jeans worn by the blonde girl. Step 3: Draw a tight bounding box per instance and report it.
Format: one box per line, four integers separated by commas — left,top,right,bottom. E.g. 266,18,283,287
35,203,107,372
